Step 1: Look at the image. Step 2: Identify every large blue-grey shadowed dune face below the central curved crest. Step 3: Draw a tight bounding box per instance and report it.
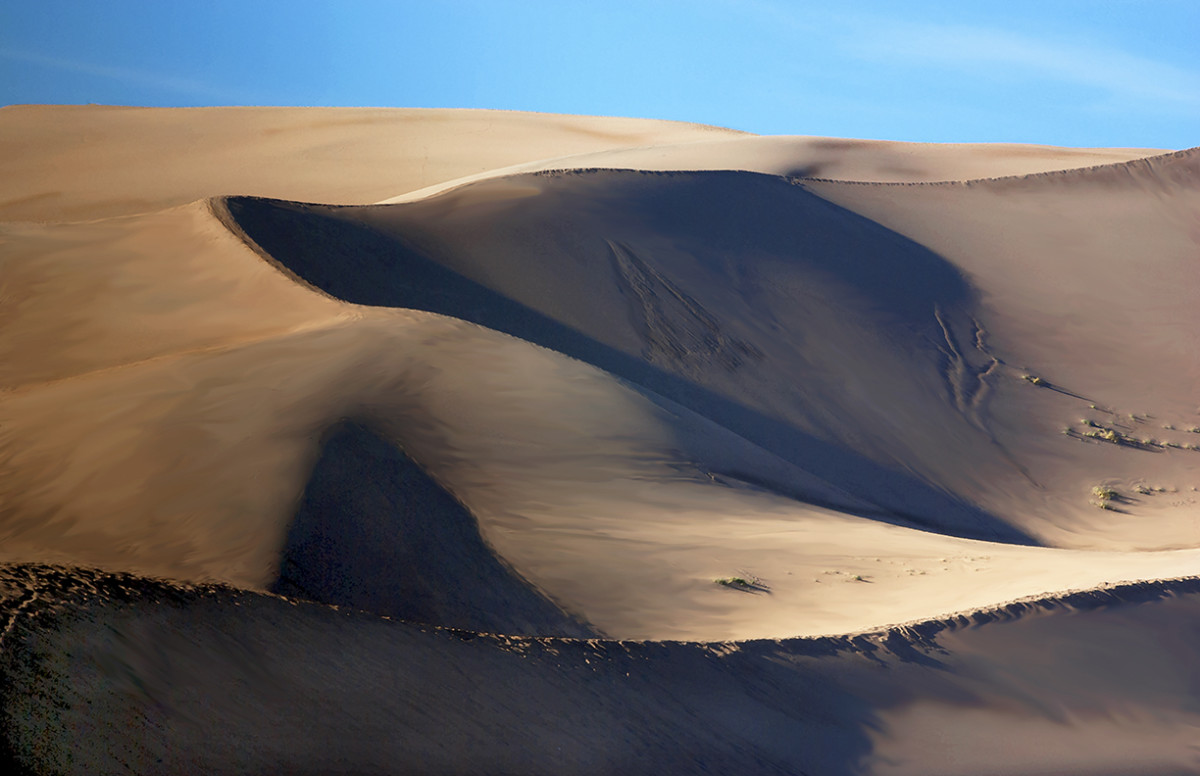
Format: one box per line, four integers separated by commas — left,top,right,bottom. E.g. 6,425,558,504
226,172,1031,543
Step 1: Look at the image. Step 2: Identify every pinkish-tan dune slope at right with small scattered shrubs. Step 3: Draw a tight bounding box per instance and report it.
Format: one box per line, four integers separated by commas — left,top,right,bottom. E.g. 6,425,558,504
804,149,1200,549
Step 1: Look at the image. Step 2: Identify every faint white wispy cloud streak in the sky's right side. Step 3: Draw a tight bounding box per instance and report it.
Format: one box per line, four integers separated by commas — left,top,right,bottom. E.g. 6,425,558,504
845,19,1200,112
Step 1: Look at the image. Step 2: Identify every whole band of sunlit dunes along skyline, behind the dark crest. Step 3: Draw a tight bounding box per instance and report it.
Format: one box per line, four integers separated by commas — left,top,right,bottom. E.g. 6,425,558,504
0,106,1157,222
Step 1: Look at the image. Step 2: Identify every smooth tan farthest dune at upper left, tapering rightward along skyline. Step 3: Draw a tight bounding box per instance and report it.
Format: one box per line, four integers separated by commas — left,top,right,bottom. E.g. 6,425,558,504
0,106,742,221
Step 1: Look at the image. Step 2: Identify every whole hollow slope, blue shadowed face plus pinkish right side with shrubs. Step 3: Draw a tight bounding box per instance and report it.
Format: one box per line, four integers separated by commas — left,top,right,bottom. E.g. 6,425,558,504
220,151,1200,549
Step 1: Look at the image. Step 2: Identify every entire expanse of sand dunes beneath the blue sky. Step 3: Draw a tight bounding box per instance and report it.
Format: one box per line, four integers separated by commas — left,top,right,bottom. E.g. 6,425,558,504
0,106,1200,775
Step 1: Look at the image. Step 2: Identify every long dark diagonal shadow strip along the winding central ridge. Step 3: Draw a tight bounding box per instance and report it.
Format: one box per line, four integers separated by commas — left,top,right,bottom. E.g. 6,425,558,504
216,176,1036,545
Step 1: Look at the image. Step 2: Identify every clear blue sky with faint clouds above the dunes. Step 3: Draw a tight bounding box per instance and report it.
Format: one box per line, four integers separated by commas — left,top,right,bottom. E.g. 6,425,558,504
0,0,1200,149
